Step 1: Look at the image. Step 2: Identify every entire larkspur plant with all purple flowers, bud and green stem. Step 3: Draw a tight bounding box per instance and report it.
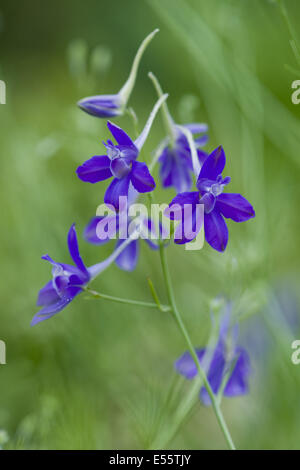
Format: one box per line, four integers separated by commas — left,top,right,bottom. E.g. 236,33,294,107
32,30,255,448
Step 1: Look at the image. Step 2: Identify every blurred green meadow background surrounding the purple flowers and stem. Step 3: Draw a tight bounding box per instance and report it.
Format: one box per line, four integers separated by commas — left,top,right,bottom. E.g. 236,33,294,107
0,0,300,449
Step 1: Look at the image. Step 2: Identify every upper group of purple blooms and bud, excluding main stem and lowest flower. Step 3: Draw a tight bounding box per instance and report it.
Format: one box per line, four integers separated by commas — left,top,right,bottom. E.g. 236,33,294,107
33,30,255,324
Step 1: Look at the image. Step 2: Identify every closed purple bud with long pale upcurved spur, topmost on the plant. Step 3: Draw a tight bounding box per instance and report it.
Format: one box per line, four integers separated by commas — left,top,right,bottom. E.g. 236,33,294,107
77,29,159,118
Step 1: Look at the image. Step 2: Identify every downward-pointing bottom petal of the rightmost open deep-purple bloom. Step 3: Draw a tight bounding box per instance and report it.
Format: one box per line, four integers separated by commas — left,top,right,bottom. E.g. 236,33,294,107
204,210,228,251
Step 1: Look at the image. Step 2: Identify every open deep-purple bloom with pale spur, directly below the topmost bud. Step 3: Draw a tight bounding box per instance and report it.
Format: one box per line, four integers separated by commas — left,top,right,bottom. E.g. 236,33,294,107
77,95,168,210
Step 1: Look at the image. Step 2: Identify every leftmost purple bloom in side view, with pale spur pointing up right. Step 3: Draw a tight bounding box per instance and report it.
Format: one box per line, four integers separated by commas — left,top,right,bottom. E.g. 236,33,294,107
31,224,135,325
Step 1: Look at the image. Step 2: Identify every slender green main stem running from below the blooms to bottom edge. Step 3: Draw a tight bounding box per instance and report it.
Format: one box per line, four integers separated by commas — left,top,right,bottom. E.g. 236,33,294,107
160,245,235,450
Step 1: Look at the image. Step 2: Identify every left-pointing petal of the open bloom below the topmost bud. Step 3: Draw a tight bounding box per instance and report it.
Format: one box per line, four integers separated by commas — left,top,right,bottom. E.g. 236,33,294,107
76,155,112,183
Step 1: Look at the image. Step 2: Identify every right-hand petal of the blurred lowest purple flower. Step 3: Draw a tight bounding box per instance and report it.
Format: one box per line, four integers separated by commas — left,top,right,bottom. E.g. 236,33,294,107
224,347,251,397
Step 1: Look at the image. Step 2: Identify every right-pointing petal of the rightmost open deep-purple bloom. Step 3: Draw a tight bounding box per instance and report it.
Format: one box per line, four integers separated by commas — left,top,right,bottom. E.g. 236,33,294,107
216,193,255,222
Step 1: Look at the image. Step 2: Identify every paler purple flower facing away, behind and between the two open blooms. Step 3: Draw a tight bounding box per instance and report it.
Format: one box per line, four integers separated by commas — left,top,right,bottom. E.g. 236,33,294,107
159,124,208,193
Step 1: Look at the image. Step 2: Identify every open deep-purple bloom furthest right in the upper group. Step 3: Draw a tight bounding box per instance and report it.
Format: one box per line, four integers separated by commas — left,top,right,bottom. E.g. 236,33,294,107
166,147,255,251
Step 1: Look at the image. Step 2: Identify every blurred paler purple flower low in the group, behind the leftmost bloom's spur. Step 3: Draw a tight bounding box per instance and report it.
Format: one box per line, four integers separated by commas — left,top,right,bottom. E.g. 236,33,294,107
84,214,162,271
